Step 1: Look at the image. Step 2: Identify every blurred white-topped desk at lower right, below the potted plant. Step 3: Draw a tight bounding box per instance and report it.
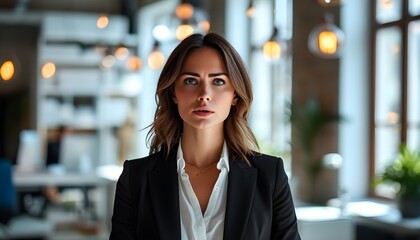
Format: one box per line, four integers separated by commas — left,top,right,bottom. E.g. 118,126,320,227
296,200,420,240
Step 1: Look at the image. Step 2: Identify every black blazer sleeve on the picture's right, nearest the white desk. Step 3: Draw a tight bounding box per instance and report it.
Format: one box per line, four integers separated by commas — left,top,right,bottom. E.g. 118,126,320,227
271,158,300,240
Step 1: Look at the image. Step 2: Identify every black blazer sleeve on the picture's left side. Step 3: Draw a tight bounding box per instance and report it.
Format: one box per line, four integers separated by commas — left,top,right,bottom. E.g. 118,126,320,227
109,161,137,240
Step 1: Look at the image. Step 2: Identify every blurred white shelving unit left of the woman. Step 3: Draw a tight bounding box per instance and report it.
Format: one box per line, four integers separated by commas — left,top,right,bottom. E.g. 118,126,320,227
37,12,140,171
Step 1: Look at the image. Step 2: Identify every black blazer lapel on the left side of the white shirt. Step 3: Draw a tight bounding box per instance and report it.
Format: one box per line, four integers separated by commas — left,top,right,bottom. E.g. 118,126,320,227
148,151,181,240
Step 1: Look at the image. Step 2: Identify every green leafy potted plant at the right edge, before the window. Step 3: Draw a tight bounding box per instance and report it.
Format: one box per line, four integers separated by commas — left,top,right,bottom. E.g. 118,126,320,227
379,144,420,218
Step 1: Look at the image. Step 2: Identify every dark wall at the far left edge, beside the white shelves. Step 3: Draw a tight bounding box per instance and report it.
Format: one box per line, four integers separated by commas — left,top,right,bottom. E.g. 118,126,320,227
0,24,39,162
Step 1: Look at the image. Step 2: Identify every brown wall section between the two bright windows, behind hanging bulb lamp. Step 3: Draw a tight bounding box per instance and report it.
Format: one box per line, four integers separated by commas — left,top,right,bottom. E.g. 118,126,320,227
292,1,340,204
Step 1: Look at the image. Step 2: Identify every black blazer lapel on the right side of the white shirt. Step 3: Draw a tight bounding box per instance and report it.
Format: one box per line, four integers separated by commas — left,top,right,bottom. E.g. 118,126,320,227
224,161,257,239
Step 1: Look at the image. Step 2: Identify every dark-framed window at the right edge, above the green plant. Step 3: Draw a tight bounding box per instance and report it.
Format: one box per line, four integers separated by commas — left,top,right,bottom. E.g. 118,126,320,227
370,0,420,197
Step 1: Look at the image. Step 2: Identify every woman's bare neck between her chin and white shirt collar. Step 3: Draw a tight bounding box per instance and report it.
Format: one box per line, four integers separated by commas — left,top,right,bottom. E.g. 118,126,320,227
181,124,224,168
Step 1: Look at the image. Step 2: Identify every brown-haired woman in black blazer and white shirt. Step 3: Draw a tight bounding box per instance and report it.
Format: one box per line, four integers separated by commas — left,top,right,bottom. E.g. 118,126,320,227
110,33,300,240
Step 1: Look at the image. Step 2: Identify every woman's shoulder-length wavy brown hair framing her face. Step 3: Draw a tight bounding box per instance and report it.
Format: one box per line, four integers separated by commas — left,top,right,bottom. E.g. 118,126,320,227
147,33,259,163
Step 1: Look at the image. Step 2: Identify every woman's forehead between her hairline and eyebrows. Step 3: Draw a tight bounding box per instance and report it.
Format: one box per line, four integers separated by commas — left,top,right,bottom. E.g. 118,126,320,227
182,47,226,72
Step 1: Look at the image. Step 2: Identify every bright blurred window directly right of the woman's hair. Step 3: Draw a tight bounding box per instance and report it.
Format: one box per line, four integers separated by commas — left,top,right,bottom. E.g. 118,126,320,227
249,0,293,171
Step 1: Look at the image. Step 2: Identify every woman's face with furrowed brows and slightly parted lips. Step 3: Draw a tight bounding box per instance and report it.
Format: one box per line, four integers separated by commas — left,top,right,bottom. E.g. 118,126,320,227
173,47,236,129
